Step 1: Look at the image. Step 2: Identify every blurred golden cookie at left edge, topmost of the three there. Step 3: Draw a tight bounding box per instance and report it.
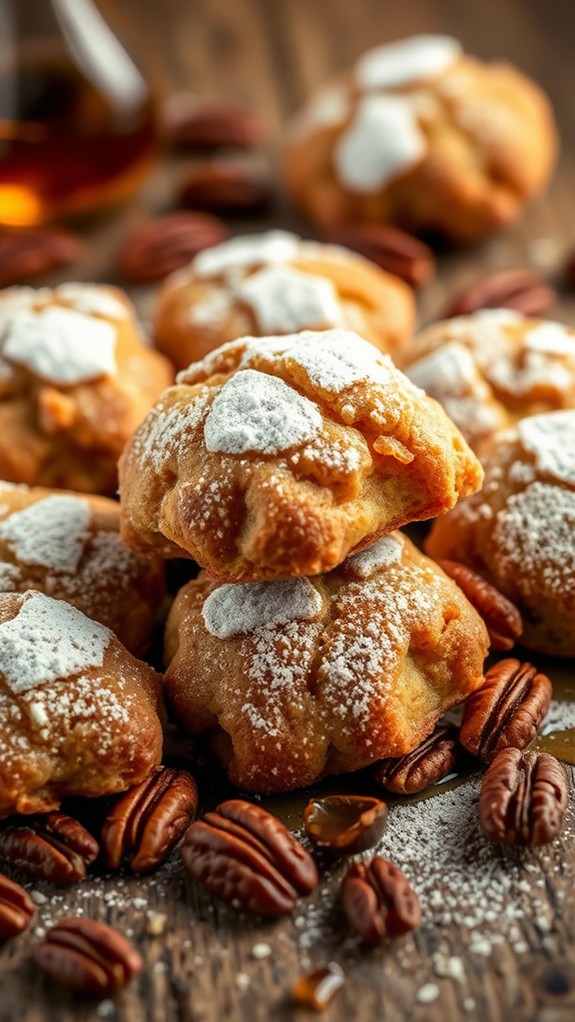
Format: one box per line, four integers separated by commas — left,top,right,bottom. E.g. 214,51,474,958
0,283,173,494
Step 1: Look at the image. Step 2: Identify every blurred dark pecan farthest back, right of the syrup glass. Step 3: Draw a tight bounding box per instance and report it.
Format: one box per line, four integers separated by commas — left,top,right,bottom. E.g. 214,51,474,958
165,102,268,151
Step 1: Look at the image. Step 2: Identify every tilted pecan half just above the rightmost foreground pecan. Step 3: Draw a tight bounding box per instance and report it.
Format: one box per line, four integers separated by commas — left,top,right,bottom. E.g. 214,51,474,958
460,659,553,762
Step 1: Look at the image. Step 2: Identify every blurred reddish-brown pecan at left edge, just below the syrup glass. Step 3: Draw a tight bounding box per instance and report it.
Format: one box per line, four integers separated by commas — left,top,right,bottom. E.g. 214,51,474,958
0,227,82,287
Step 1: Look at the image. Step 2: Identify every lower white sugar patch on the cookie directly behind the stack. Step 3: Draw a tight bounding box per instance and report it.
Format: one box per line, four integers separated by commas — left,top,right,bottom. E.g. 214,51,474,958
237,267,341,333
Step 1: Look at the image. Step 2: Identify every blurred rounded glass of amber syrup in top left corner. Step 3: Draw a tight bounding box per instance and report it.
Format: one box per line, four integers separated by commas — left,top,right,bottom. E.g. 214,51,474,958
0,0,158,227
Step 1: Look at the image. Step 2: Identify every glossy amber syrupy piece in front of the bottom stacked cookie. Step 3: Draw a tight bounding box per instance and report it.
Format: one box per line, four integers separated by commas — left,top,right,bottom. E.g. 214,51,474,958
303,795,387,855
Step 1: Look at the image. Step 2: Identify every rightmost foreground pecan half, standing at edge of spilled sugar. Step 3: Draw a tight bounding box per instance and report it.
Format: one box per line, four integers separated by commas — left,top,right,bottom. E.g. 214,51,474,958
479,749,567,846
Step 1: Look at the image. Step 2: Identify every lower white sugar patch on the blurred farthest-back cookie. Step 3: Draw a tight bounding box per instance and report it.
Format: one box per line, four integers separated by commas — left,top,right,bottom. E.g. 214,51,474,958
333,95,427,193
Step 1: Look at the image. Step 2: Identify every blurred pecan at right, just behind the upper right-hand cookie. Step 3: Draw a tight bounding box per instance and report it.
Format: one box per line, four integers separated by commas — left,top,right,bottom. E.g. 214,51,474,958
443,270,557,319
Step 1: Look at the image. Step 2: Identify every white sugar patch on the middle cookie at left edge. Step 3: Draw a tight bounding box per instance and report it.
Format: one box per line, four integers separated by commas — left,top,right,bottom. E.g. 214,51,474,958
0,495,91,572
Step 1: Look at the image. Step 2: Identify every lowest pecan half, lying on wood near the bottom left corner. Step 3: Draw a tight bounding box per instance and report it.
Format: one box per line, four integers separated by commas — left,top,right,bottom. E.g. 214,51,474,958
33,918,142,994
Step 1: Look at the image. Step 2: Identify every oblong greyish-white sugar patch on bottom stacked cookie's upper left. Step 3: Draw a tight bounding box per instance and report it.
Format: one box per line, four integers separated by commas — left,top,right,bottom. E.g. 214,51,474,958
202,578,322,639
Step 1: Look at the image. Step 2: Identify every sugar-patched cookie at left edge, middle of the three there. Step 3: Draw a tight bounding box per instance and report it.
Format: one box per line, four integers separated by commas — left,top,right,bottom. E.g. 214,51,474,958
0,481,165,655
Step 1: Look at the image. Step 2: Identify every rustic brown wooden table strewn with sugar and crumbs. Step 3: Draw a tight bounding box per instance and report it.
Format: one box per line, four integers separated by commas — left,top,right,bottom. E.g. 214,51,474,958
0,0,575,1022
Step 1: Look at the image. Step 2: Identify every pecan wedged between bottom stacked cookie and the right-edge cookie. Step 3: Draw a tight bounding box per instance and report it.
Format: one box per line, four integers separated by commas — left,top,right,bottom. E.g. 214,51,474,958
437,560,523,650
